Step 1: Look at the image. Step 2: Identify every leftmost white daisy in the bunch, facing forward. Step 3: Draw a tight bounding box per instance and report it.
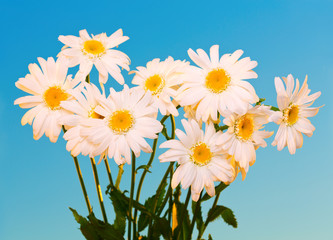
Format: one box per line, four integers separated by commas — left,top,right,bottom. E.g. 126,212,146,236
14,57,77,142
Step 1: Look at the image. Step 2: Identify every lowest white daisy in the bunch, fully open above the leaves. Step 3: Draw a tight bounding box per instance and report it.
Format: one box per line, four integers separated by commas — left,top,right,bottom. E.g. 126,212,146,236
159,119,233,201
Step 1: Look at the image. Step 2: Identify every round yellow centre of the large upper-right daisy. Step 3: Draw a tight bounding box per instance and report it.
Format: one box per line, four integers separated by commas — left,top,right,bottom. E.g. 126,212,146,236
206,68,230,93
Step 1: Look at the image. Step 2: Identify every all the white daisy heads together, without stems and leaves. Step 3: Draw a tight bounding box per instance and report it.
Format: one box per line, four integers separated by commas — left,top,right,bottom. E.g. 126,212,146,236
15,29,320,201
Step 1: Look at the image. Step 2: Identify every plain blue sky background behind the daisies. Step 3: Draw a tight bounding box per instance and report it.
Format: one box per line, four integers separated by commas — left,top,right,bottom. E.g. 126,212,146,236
0,0,333,240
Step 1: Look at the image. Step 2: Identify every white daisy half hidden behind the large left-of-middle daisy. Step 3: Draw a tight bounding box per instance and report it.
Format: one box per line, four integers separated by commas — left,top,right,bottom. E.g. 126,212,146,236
60,82,105,157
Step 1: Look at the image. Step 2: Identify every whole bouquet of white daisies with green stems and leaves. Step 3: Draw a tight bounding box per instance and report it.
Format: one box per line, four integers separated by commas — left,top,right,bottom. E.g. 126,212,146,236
14,29,320,240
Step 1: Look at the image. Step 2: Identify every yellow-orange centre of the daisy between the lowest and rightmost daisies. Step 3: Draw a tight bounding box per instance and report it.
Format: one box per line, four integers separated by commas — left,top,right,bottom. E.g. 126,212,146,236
235,114,254,141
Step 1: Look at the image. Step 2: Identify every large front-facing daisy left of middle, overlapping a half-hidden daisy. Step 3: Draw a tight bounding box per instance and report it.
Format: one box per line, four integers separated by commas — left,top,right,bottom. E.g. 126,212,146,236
77,84,163,165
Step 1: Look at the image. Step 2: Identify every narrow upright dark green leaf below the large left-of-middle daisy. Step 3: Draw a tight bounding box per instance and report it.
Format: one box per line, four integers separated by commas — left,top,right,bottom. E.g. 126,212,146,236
109,187,128,235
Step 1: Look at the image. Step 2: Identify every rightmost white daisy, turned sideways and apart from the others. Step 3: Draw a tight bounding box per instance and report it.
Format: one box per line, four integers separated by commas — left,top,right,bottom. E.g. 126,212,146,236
271,74,321,154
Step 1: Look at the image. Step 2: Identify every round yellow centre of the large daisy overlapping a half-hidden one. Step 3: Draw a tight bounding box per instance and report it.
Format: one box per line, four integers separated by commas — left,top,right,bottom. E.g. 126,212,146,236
109,110,134,134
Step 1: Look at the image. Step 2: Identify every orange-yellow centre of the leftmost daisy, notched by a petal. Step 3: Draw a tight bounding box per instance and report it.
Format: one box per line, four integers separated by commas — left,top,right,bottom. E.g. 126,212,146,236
43,86,69,110
